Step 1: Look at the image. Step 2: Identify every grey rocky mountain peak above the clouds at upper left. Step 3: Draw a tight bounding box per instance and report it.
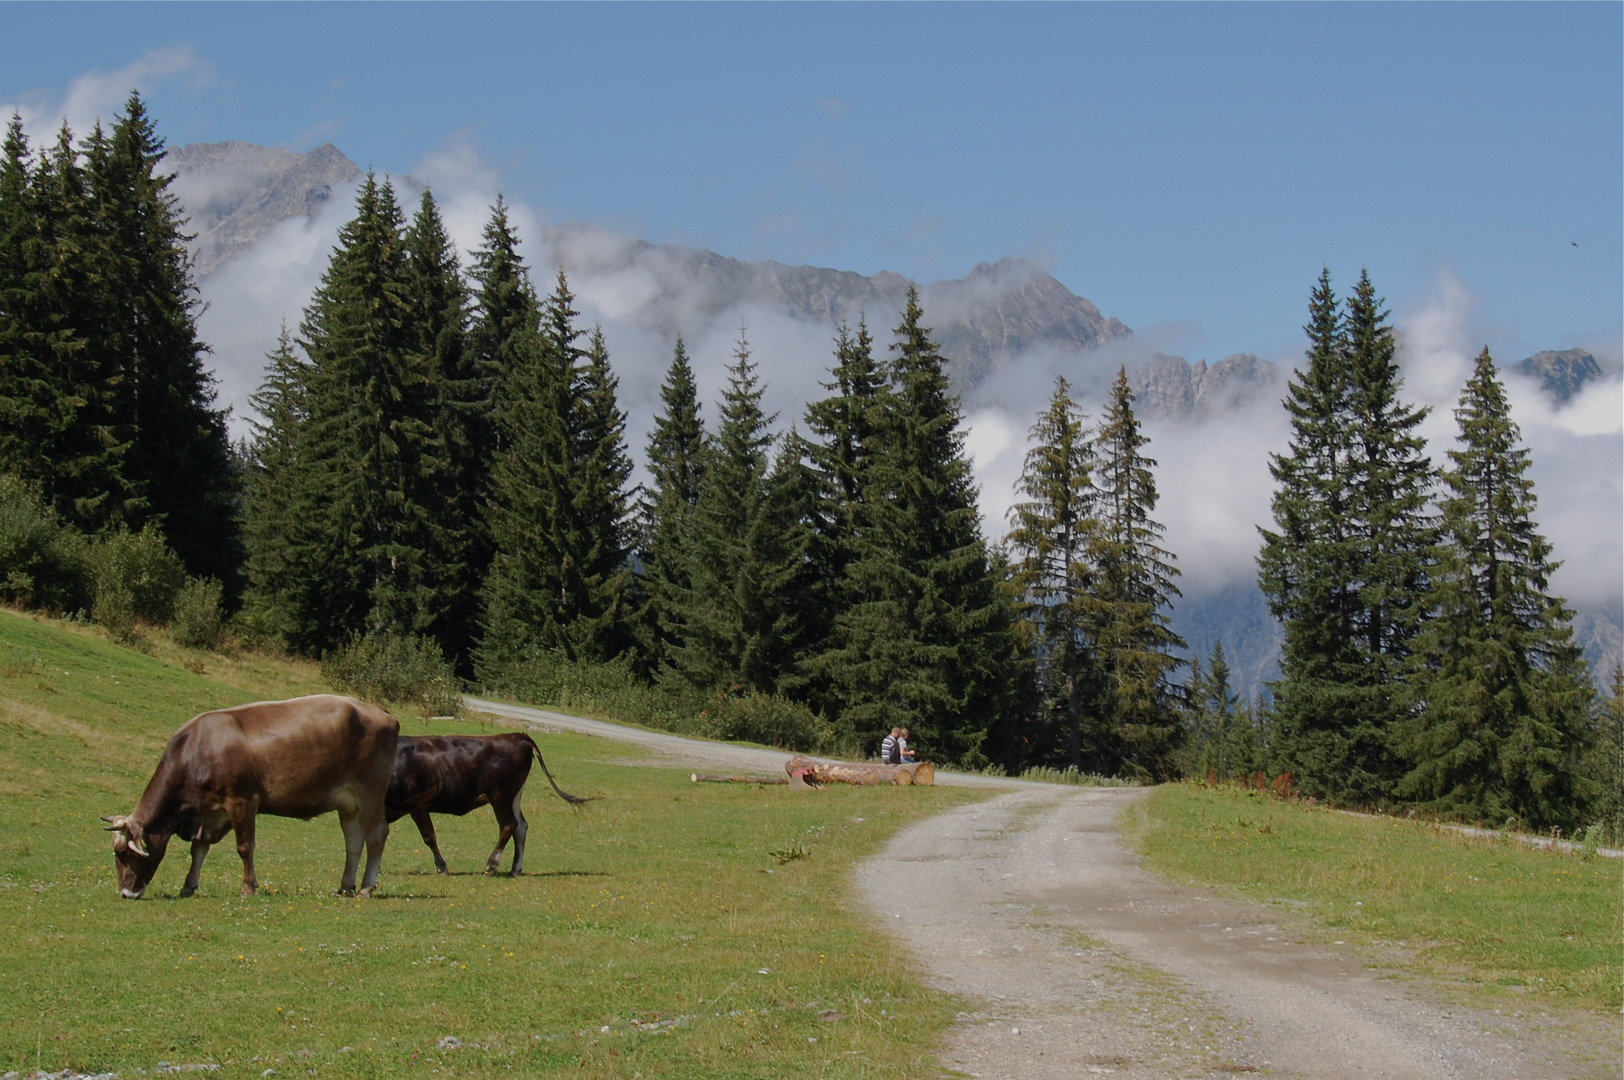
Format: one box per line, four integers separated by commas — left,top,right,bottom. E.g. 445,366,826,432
166,143,361,276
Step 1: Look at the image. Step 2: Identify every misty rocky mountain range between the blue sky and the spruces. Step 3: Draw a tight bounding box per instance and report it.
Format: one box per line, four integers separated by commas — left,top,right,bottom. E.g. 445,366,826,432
169,143,1624,692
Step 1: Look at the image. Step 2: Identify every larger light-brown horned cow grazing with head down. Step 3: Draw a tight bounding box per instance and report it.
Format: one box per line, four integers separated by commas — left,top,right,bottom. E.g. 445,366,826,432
102,693,400,900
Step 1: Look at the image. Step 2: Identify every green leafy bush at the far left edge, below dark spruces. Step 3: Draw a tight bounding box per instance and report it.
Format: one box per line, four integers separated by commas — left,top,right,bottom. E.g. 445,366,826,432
0,474,89,611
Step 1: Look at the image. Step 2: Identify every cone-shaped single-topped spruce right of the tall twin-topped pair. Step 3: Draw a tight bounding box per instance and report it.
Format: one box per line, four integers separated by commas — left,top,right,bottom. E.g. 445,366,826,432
1400,349,1595,828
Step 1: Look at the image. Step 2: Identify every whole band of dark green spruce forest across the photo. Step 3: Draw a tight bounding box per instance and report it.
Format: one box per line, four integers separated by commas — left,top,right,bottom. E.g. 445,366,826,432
0,94,1624,836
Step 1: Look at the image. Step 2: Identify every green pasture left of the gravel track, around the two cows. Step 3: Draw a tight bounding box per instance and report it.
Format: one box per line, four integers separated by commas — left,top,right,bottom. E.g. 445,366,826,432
0,611,984,1077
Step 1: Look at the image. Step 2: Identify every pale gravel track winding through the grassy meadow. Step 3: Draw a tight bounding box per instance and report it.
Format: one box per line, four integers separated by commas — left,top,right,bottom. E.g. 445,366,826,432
469,700,1621,1080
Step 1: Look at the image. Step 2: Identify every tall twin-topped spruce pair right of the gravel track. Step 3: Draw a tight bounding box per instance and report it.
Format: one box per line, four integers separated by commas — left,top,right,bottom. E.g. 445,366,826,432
1259,271,1434,802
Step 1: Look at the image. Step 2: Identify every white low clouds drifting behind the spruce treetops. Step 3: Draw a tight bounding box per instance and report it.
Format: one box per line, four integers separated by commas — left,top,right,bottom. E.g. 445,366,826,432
184,138,1624,623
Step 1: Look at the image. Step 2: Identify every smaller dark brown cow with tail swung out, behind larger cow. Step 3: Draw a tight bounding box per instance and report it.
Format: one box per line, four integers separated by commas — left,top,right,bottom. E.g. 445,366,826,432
387,732,586,875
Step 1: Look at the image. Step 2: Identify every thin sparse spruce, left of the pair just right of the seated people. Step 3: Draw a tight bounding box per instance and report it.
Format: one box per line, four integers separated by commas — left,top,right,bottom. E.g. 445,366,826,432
1009,377,1099,770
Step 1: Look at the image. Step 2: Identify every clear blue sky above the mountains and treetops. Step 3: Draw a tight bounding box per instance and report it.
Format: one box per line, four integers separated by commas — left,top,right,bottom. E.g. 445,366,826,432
0,3,1624,359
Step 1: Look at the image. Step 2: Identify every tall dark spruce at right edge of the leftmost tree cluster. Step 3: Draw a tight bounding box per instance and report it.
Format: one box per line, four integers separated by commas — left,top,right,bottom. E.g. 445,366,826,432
88,93,242,593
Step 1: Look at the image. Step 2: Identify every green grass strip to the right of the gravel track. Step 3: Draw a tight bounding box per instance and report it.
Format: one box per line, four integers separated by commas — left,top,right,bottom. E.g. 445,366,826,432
1124,784,1624,1013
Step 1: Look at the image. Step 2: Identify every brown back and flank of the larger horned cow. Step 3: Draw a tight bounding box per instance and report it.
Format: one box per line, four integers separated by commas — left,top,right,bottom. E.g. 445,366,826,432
185,693,400,817
